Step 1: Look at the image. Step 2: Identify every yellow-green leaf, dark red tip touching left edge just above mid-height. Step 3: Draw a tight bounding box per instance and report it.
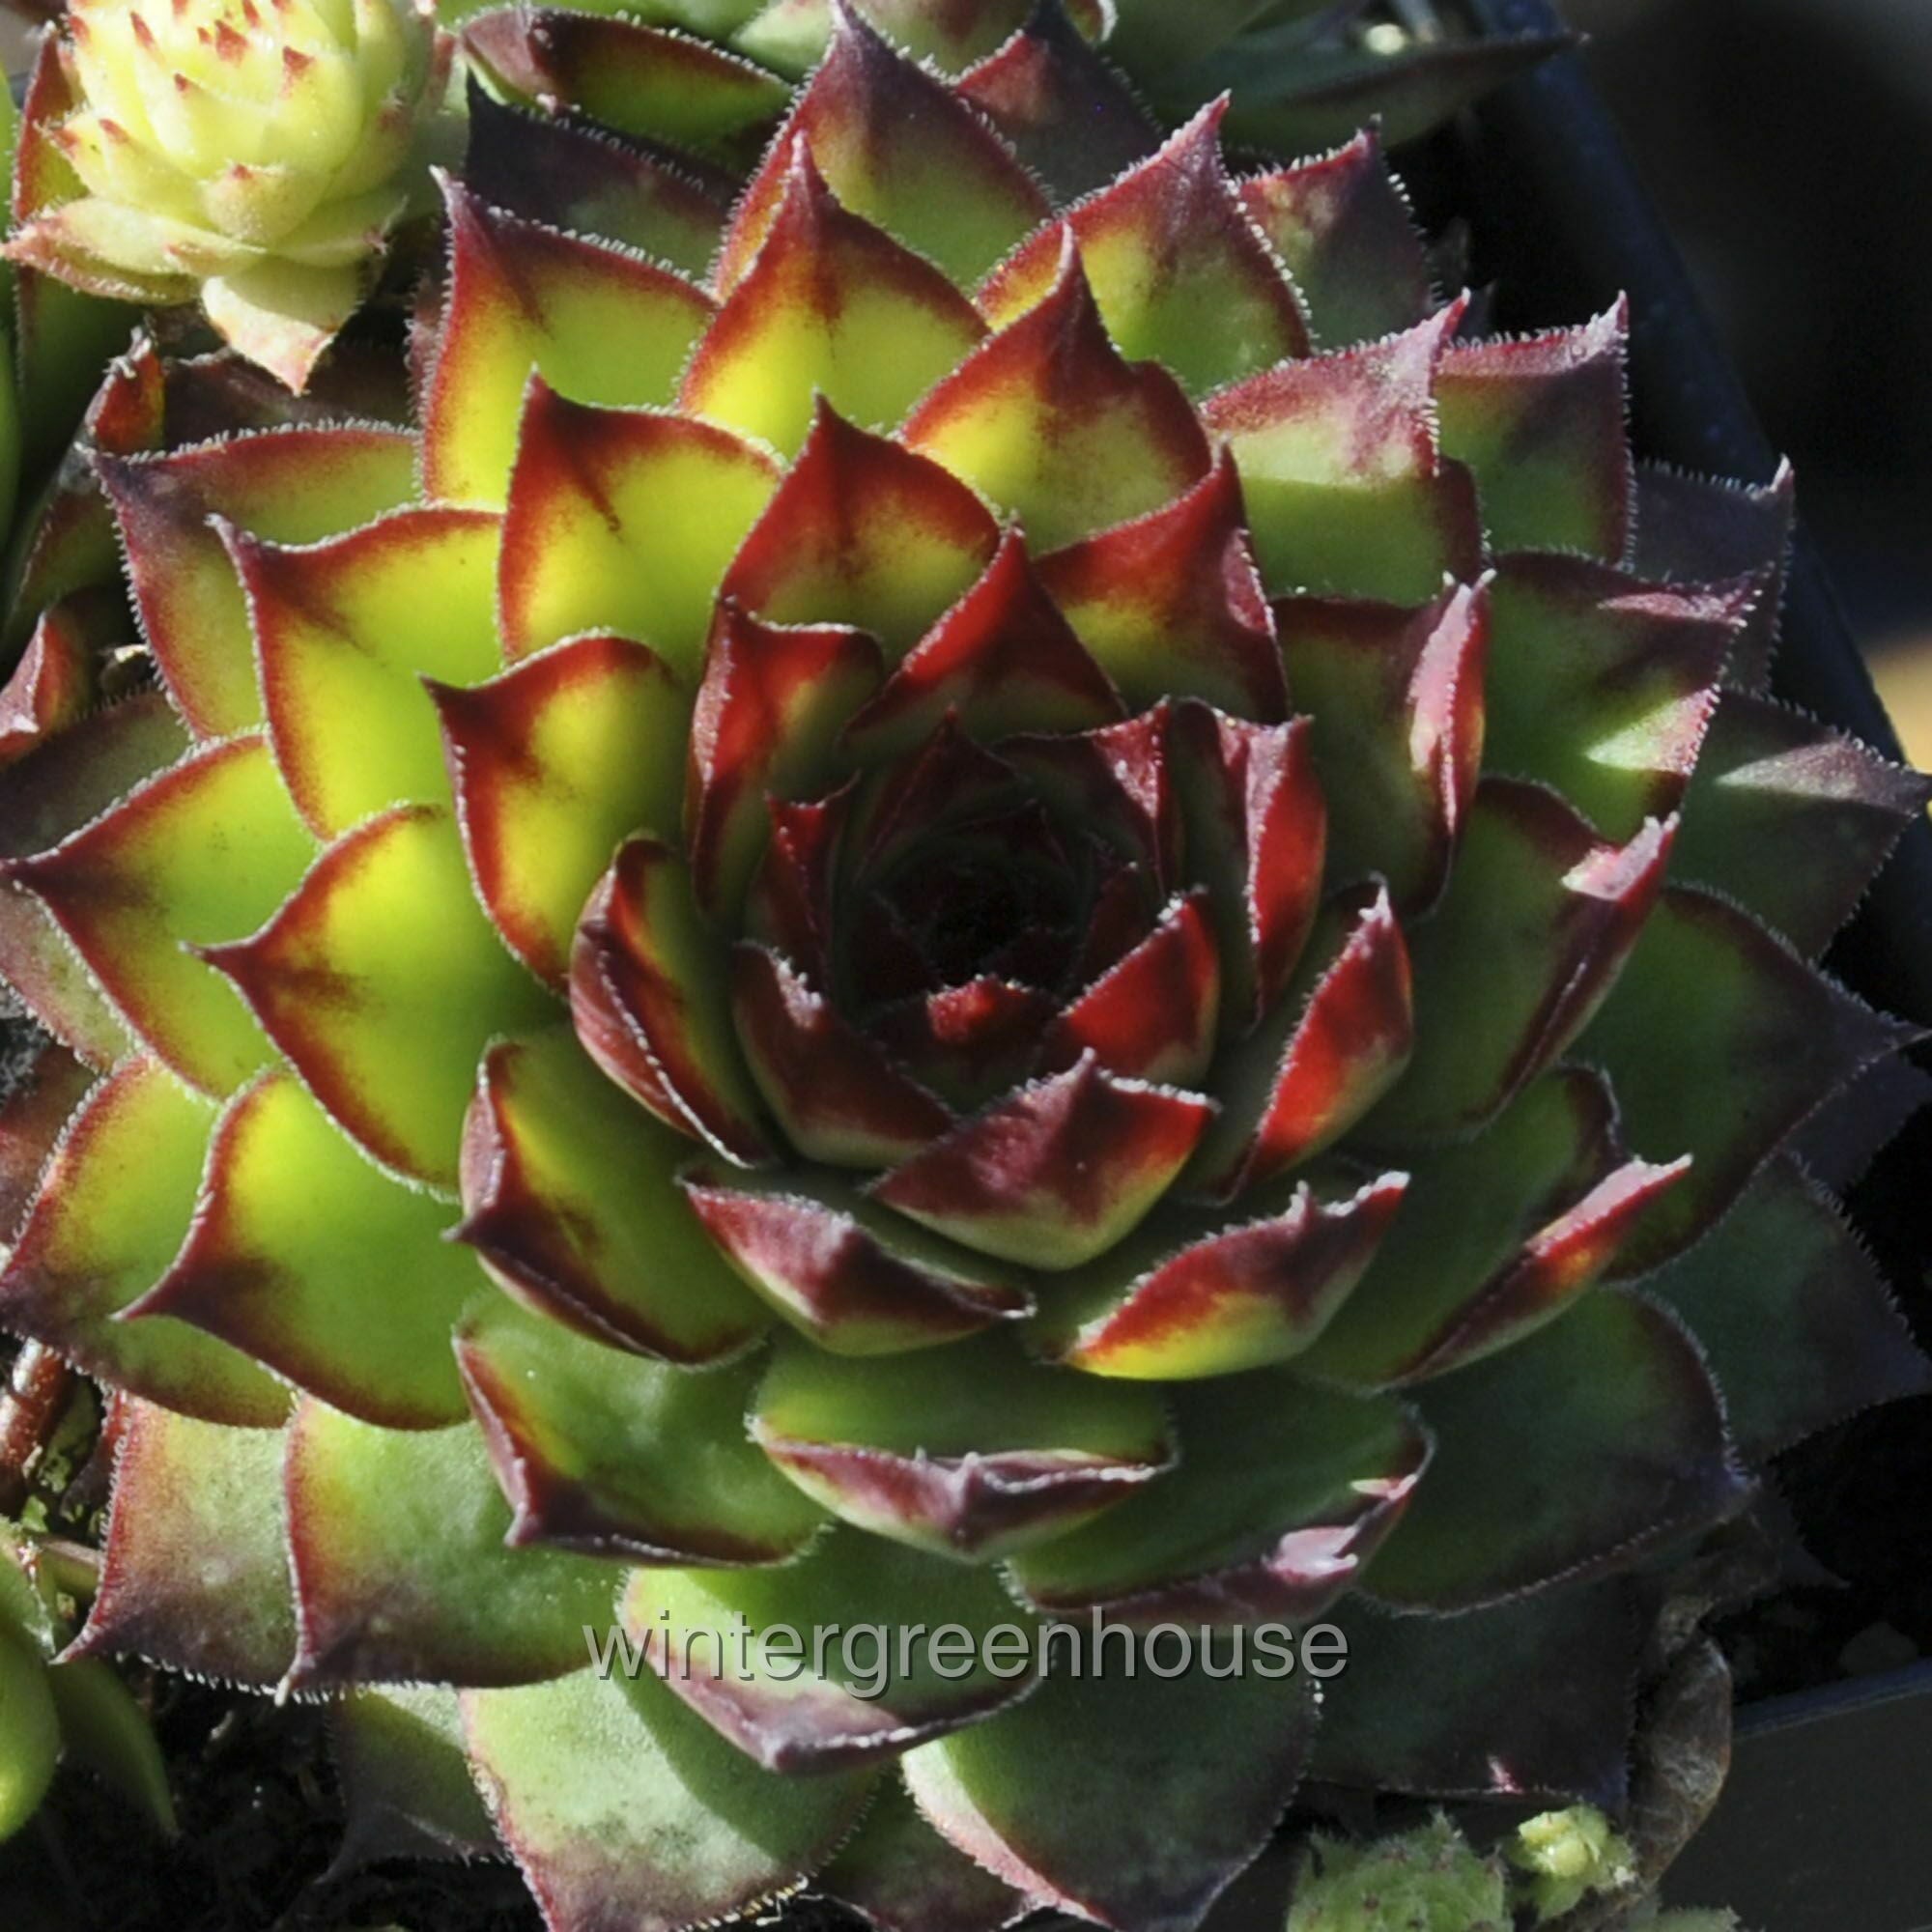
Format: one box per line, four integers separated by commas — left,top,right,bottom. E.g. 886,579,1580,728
6,734,315,1094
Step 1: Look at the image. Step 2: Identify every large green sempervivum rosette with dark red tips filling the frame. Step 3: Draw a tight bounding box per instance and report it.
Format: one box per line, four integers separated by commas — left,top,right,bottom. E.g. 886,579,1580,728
0,12,1924,1932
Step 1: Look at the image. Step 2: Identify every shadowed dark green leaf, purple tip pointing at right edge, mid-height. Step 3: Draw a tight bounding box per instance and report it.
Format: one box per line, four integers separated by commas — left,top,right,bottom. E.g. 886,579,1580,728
1577,887,1918,1275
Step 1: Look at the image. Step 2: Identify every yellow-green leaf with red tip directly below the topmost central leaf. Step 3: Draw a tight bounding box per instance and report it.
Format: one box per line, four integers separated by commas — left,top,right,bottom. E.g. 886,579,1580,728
678,141,985,456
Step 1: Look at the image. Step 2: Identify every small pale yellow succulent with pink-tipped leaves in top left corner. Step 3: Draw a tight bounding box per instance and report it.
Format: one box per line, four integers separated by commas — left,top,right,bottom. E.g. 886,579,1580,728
6,0,448,390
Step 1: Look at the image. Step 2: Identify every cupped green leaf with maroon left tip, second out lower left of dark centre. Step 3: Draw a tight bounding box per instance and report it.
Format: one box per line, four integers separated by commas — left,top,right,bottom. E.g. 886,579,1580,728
454,1026,767,1368
